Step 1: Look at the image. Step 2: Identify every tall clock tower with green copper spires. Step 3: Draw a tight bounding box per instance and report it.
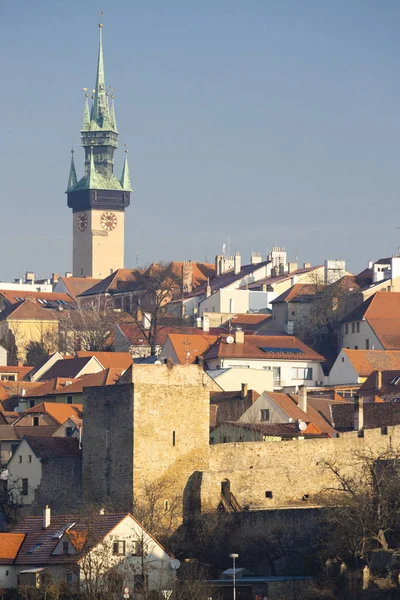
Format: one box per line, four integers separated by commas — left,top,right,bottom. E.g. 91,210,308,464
66,23,132,279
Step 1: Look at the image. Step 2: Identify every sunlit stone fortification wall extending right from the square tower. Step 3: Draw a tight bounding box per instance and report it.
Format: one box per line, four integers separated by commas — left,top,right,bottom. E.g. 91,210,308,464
197,427,400,511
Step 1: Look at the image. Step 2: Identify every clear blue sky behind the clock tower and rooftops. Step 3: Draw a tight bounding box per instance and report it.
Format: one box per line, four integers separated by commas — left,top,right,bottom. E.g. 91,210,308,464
0,0,400,281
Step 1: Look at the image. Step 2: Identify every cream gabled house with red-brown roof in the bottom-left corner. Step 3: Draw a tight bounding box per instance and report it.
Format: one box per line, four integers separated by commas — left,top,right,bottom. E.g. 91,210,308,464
0,506,175,597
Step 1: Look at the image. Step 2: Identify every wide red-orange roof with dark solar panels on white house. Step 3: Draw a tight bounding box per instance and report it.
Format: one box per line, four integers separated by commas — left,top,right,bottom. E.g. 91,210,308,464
204,334,325,362
